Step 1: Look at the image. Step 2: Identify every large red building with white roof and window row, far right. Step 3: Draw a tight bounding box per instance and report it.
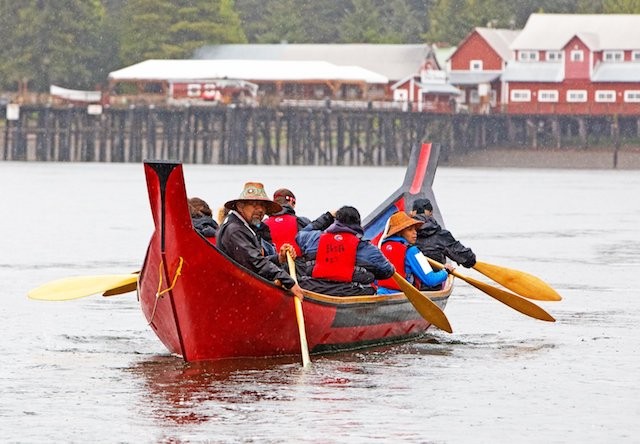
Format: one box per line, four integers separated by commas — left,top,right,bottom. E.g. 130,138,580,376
502,14,640,115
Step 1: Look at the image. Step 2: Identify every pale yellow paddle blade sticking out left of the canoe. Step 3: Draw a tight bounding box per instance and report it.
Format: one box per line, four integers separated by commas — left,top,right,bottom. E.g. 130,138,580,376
28,274,138,301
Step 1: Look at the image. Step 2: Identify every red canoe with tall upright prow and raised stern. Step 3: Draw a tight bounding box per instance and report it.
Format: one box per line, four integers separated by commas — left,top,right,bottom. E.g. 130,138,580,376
138,144,452,361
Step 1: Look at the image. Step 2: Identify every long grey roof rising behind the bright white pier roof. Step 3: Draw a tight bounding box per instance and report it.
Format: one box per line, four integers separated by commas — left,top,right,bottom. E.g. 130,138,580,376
193,43,432,81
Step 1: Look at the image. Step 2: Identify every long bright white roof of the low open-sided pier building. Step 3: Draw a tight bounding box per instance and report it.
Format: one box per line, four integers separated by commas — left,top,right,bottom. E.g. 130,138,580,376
109,60,389,84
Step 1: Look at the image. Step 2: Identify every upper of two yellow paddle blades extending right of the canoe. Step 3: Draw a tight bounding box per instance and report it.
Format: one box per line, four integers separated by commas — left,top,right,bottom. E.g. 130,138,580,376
473,262,562,301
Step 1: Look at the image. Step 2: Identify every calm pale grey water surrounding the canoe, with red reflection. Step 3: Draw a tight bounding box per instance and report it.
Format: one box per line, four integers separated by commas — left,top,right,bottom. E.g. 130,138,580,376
0,163,640,443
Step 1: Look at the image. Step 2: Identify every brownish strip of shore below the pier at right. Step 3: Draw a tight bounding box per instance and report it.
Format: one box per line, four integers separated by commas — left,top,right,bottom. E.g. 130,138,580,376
440,147,640,170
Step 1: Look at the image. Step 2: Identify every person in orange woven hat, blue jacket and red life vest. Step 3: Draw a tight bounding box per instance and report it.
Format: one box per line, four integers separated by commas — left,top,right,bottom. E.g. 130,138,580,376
378,211,453,294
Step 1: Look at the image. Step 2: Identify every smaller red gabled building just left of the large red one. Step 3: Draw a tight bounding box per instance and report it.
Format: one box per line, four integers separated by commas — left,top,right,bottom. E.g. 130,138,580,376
447,28,520,113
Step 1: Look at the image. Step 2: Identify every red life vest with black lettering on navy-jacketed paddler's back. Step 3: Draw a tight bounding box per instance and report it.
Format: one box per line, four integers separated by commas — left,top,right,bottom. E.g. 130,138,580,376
311,233,360,282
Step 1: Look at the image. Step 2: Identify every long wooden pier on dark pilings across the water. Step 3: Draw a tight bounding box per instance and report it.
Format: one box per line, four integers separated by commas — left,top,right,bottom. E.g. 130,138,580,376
0,106,640,166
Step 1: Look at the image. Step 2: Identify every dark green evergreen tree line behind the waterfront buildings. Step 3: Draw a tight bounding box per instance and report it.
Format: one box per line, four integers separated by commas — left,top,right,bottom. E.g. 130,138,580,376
0,0,640,92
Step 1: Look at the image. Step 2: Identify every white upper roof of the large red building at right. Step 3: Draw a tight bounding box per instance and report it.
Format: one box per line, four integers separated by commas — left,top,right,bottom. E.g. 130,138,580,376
511,14,640,50
